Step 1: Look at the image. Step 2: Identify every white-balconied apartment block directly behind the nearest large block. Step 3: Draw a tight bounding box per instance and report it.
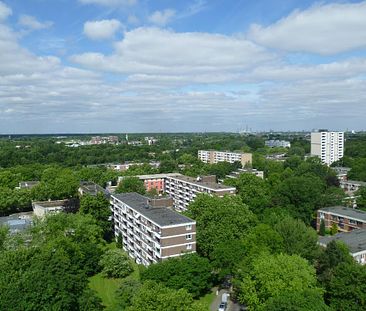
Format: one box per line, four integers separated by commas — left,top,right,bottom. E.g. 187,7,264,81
165,175,236,211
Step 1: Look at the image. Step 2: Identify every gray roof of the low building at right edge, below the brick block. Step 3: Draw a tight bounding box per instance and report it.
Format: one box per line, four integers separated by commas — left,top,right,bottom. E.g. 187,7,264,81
319,229,366,254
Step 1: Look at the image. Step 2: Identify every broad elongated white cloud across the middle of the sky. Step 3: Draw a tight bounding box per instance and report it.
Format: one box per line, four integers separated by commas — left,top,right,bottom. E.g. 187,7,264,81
71,28,273,78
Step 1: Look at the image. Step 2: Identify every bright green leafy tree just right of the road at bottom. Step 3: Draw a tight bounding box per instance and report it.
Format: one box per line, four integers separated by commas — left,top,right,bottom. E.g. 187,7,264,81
238,254,322,310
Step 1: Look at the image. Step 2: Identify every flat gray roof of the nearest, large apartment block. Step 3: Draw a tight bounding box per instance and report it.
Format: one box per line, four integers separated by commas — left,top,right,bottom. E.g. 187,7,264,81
112,192,195,227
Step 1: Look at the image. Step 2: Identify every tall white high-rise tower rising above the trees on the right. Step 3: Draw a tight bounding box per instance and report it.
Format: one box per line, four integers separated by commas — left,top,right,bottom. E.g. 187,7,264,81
311,131,344,165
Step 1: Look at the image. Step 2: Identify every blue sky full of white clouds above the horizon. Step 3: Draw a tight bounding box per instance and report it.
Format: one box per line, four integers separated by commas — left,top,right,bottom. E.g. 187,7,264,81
0,0,366,134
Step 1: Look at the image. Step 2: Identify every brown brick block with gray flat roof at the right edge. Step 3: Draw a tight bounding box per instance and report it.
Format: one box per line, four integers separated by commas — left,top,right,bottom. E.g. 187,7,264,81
316,206,366,232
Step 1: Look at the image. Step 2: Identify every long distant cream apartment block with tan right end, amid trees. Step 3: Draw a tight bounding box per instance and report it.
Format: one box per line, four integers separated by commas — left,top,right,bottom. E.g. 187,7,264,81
198,150,252,166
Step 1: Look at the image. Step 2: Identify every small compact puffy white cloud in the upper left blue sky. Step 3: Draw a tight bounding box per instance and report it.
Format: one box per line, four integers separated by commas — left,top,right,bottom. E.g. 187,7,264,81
84,19,122,40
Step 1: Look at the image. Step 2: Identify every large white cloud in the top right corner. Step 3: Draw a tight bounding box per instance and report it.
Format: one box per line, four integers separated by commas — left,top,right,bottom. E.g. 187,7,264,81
248,2,366,55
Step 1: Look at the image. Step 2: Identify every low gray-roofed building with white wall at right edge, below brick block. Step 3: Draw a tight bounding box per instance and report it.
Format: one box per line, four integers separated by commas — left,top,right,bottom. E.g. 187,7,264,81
319,229,366,265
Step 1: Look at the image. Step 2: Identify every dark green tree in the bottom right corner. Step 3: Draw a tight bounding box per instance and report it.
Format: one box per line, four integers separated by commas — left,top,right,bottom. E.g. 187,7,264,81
326,263,366,311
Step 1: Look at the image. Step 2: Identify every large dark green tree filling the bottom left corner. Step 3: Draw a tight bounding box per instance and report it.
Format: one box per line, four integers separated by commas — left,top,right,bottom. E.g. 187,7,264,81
0,247,87,310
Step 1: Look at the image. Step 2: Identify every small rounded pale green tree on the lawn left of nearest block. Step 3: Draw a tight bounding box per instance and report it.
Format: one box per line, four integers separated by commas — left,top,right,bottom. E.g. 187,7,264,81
99,249,133,278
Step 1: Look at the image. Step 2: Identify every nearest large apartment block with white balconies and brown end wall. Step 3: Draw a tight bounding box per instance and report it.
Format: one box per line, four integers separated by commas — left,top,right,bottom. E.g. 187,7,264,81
111,193,196,266
